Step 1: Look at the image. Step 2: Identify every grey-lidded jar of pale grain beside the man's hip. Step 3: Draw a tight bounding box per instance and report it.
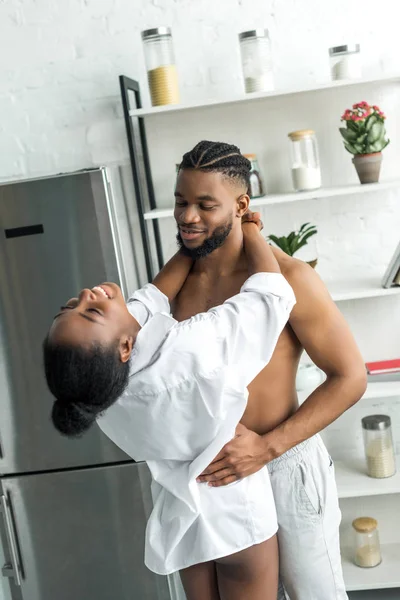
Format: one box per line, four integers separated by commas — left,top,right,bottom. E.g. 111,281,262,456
361,415,396,479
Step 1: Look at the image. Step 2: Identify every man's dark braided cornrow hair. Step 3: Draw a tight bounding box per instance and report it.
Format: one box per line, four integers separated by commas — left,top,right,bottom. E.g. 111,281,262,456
179,140,251,191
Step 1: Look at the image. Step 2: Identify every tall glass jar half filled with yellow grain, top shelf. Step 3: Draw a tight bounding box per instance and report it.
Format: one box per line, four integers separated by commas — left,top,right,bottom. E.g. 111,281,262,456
142,27,180,106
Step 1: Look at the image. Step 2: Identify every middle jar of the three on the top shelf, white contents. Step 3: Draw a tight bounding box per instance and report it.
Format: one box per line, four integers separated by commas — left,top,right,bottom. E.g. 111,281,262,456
239,29,274,94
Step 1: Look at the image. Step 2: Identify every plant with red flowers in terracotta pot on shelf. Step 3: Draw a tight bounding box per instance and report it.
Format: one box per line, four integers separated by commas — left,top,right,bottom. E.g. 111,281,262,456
339,102,390,183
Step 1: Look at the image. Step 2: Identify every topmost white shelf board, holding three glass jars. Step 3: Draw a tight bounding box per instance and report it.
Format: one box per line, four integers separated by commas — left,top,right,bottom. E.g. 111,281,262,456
129,74,400,117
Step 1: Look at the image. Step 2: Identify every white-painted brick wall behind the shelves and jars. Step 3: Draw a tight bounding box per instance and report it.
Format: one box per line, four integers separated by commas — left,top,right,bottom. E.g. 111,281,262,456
0,0,400,596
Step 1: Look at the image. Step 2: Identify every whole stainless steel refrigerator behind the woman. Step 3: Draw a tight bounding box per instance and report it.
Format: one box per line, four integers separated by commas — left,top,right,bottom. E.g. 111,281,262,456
0,169,175,600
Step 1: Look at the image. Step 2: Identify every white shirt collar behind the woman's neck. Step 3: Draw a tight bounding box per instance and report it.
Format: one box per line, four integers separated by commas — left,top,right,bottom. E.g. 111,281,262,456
130,313,177,375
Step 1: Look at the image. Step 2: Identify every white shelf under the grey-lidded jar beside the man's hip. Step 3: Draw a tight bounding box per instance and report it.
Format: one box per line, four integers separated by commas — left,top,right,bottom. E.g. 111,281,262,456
335,457,400,500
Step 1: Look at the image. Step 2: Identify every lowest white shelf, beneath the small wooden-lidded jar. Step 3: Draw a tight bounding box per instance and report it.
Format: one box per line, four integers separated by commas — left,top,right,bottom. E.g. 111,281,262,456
342,544,400,592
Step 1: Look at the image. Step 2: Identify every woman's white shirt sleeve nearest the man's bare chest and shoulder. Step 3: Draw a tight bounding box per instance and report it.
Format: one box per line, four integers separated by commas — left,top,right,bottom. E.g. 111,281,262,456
207,273,296,385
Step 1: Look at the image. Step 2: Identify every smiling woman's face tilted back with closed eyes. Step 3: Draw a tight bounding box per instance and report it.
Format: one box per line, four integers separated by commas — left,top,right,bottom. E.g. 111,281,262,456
49,283,137,348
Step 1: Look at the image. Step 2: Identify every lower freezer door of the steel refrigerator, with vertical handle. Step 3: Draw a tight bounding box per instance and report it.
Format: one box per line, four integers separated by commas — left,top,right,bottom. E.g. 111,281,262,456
1,463,170,600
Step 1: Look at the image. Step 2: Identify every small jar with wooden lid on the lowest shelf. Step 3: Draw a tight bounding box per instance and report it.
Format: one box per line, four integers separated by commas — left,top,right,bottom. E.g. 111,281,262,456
353,517,382,568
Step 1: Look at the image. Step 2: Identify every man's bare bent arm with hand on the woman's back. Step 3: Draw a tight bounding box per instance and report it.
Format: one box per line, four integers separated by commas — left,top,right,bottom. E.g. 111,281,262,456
200,262,367,486
